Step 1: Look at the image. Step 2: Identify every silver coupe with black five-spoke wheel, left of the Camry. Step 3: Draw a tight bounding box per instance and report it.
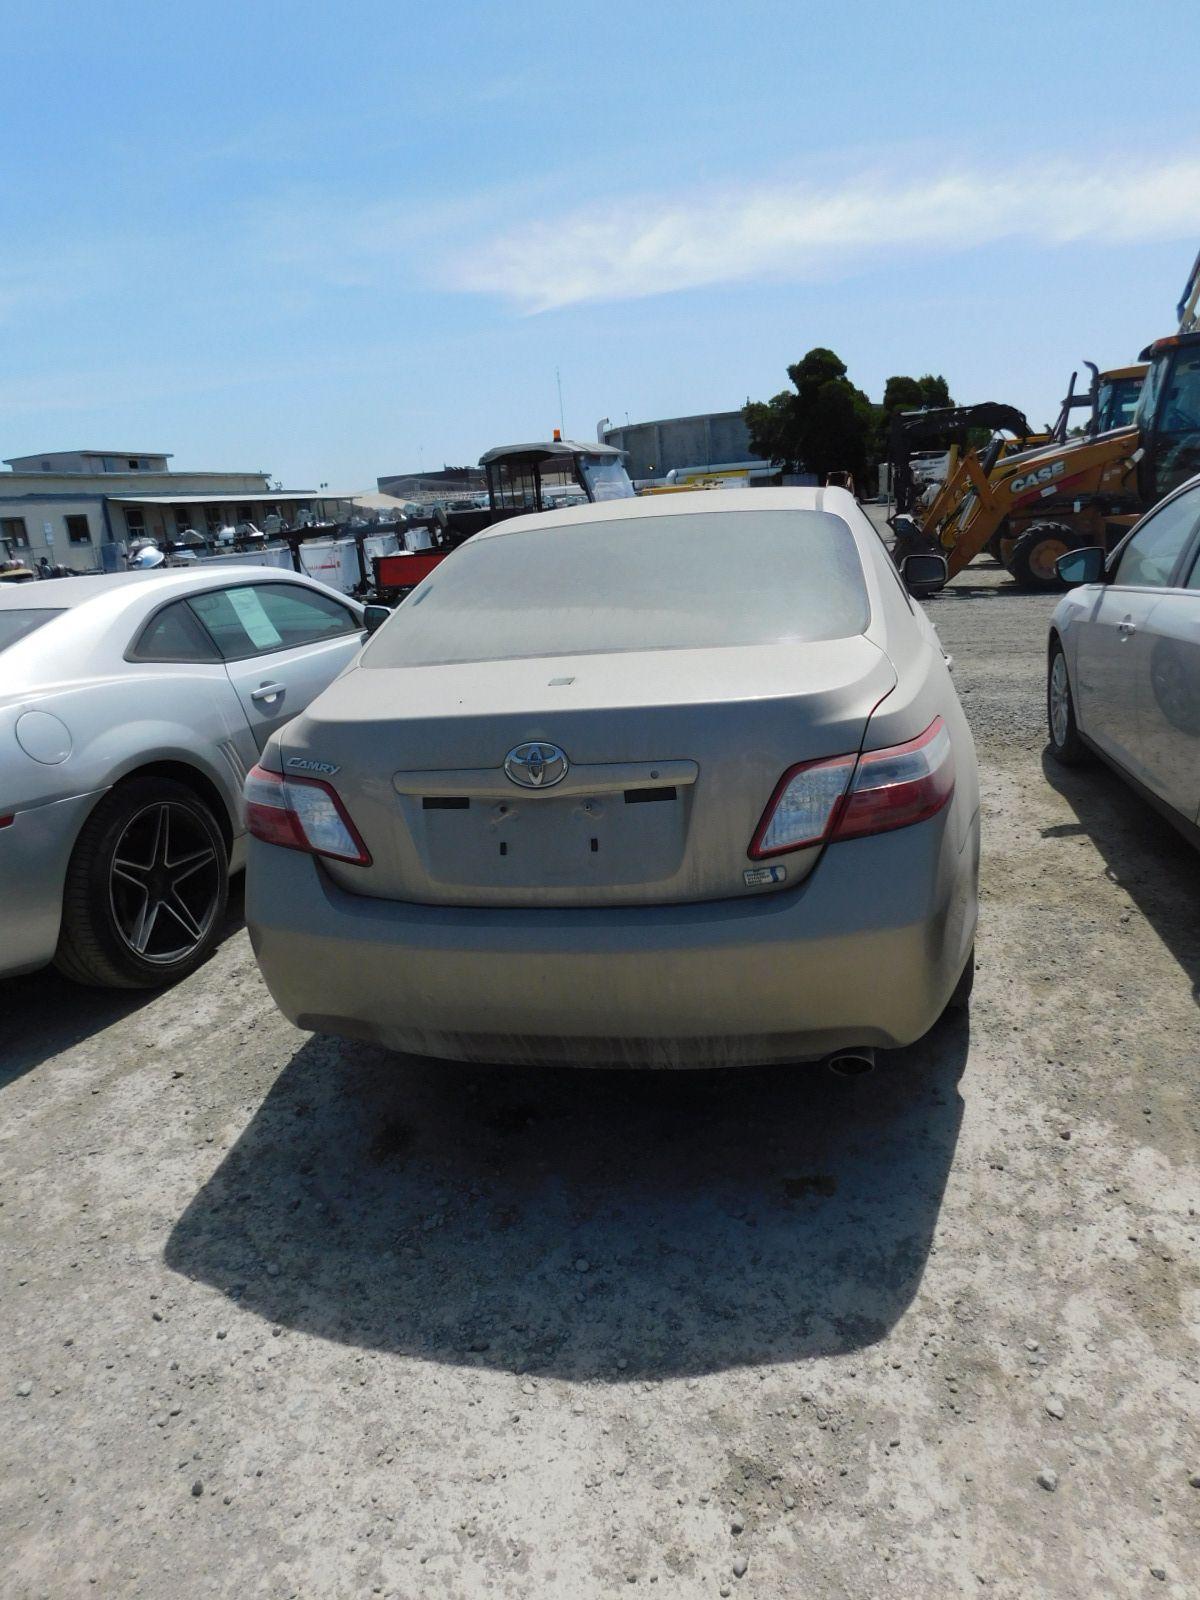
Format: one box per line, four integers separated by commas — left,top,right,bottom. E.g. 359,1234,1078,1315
0,568,363,989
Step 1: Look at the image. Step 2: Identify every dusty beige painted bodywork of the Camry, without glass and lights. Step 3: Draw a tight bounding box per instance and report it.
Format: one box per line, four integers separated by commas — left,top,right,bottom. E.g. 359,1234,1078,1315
246,491,979,1066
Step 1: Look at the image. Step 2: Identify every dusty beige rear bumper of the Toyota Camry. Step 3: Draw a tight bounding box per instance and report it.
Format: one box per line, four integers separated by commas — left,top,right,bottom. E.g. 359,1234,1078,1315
246,813,979,1067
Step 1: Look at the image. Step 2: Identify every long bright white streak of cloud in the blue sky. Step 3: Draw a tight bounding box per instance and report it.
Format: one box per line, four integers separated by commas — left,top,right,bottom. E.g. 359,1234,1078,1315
448,157,1200,312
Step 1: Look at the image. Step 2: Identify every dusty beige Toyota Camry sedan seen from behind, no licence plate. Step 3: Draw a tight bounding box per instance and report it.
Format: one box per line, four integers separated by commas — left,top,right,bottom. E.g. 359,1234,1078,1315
245,490,979,1067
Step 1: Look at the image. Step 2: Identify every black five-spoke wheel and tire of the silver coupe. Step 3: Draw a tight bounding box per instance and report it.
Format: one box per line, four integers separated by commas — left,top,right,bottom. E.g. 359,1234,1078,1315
54,778,229,989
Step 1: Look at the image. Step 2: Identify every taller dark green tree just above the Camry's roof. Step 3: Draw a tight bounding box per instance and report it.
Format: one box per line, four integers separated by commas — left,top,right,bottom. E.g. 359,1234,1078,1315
742,355,878,485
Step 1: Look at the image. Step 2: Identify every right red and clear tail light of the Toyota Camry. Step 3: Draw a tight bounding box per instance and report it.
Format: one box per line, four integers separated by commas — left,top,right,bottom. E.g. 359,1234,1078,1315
747,717,954,861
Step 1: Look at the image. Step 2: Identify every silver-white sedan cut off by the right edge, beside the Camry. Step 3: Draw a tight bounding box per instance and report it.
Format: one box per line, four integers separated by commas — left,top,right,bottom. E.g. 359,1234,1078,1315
1046,478,1200,845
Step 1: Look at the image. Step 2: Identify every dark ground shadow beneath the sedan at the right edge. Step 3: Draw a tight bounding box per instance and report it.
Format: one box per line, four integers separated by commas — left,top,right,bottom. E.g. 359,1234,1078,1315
1042,749,1200,1003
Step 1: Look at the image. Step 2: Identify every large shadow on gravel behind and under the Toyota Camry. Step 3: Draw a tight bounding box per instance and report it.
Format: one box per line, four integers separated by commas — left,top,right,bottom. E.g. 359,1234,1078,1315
166,1014,970,1381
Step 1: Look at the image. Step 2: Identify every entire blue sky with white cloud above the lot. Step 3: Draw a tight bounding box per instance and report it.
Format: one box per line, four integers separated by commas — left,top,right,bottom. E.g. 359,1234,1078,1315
0,0,1200,488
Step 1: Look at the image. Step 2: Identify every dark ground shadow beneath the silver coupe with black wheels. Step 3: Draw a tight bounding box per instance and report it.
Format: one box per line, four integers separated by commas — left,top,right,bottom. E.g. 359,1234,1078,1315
0,874,245,1090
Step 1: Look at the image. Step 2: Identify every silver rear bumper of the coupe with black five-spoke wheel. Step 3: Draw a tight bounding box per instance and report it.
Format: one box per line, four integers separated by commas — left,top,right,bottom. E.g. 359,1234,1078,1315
0,789,104,978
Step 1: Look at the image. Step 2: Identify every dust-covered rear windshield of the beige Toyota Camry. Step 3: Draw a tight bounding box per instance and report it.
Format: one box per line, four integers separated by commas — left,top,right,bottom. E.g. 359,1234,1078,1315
362,510,870,667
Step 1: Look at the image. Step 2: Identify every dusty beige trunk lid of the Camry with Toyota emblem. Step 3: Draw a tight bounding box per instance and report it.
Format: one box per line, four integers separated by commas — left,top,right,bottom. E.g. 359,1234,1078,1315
282,635,896,907
